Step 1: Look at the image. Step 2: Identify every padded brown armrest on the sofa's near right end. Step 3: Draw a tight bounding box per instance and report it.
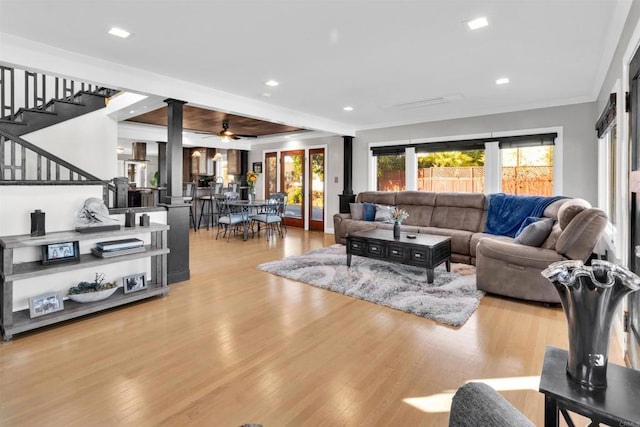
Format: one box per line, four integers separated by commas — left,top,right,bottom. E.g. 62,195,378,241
476,237,566,270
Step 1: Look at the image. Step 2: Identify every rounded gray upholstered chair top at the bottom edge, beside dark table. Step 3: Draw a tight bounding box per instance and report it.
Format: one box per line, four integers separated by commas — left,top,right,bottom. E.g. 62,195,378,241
449,382,534,427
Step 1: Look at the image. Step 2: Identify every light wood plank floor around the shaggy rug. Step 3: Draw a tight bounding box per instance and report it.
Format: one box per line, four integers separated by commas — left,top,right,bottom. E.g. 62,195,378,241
0,229,622,427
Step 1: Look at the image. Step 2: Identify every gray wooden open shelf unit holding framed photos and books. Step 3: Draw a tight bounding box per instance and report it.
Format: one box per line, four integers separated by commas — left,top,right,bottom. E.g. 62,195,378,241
0,224,169,341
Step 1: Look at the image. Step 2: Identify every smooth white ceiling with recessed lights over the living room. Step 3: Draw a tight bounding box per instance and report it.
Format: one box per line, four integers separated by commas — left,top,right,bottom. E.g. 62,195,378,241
0,0,631,132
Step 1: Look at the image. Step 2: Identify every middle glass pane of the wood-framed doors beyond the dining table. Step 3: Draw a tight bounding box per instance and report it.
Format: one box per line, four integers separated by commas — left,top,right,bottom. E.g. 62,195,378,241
280,150,305,228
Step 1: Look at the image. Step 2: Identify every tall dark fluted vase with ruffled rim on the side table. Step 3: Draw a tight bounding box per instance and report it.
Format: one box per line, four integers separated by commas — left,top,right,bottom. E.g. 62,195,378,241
541,260,640,390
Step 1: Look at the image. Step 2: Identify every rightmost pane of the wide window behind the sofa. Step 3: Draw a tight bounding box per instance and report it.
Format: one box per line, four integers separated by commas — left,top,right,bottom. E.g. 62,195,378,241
500,145,553,196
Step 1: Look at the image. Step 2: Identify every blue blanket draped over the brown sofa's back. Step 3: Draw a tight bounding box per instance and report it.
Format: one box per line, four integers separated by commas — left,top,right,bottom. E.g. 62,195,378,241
484,193,565,237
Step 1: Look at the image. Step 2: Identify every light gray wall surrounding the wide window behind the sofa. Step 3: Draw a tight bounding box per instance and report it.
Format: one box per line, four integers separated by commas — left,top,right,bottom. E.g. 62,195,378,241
353,103,598,205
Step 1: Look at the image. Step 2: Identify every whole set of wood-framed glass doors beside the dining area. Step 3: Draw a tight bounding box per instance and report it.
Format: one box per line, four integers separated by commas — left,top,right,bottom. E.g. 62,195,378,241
265,148,325,231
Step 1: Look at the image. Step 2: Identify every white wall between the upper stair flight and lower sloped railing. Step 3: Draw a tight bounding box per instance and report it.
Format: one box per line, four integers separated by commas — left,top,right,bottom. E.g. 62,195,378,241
22,109,118,180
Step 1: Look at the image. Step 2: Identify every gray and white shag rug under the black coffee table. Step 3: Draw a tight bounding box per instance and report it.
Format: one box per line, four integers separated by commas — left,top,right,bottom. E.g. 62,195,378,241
257,245,484,326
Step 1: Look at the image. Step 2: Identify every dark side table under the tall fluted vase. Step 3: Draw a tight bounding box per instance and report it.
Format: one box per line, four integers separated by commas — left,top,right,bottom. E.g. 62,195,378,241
540,346,640,427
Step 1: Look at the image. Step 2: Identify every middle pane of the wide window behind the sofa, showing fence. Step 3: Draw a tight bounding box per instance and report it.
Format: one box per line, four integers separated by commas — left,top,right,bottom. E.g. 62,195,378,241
417,150,484,193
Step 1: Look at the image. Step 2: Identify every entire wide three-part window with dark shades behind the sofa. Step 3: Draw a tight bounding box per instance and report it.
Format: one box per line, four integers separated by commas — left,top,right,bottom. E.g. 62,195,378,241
371,132,562,196
